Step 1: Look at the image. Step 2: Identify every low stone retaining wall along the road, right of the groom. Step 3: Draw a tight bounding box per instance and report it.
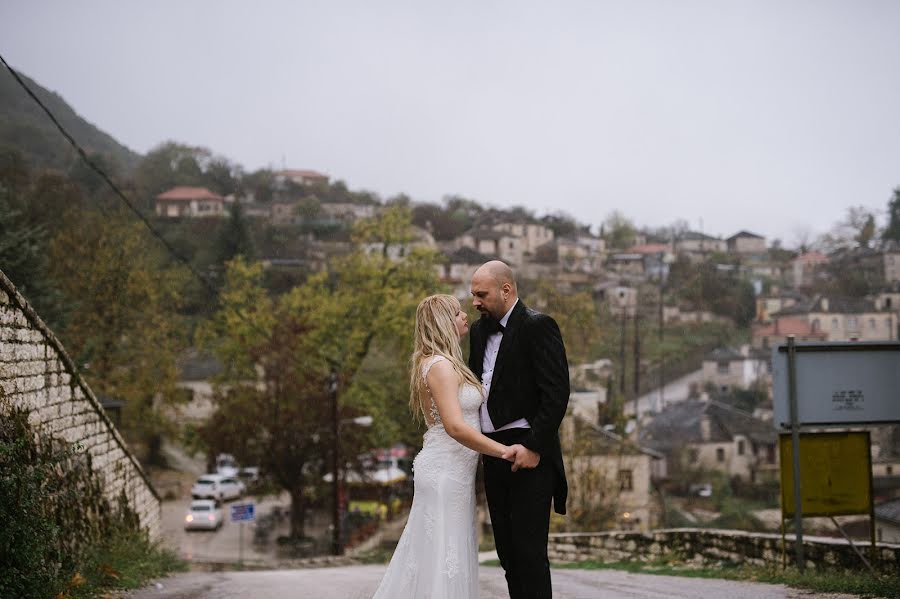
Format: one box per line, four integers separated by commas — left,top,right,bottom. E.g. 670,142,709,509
549,528,900,572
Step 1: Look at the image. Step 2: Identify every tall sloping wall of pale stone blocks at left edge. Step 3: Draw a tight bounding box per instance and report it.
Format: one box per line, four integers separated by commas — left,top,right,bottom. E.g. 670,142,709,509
0,272,161,539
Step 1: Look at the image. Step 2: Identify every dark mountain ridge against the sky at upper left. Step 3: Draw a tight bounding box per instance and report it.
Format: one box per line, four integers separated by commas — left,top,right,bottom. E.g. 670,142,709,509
0,67,141,175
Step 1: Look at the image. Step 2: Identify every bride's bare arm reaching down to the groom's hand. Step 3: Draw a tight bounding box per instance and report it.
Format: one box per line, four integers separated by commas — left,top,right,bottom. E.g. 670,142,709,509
427,360,510,458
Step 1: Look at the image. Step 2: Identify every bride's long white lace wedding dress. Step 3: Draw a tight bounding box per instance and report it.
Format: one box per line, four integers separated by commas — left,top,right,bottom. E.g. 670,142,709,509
373,356,482,599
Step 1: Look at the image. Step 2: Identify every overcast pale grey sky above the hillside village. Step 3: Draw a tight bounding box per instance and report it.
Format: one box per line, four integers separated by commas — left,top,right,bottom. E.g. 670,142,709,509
0,0,900,245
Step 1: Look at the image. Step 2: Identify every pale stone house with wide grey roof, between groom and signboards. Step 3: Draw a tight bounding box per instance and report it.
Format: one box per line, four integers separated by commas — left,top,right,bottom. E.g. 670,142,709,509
639,400,778,483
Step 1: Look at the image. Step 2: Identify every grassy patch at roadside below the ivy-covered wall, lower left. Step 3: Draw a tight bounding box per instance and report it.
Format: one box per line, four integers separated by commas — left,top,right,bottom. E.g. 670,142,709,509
63,530,188,599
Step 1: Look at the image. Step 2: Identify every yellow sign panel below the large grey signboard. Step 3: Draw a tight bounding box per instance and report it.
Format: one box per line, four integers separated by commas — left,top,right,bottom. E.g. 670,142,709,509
778,432,872,517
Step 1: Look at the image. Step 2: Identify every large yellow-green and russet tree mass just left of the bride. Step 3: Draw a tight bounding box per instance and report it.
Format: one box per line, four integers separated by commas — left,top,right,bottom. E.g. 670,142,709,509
201,207,438,537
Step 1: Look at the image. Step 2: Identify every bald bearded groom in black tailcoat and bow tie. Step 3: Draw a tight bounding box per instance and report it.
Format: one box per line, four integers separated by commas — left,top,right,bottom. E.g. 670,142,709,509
469,260,569,599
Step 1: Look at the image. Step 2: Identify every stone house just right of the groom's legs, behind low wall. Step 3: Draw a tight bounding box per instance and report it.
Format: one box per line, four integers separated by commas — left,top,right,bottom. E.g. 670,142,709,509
560,413,665,532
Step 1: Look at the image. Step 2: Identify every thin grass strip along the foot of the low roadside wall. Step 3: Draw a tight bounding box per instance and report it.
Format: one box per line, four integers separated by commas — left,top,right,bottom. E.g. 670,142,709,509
548,561,900,599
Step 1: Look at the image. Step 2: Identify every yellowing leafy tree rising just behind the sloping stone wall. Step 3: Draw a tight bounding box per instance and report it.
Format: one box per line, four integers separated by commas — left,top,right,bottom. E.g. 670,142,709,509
49,211,186,463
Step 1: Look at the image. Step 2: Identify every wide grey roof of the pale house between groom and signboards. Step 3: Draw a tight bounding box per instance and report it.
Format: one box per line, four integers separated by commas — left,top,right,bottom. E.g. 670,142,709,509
640,400,777,453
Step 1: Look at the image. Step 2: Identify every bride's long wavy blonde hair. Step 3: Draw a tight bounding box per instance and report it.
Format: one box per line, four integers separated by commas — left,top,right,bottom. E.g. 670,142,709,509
409,294,481,419
